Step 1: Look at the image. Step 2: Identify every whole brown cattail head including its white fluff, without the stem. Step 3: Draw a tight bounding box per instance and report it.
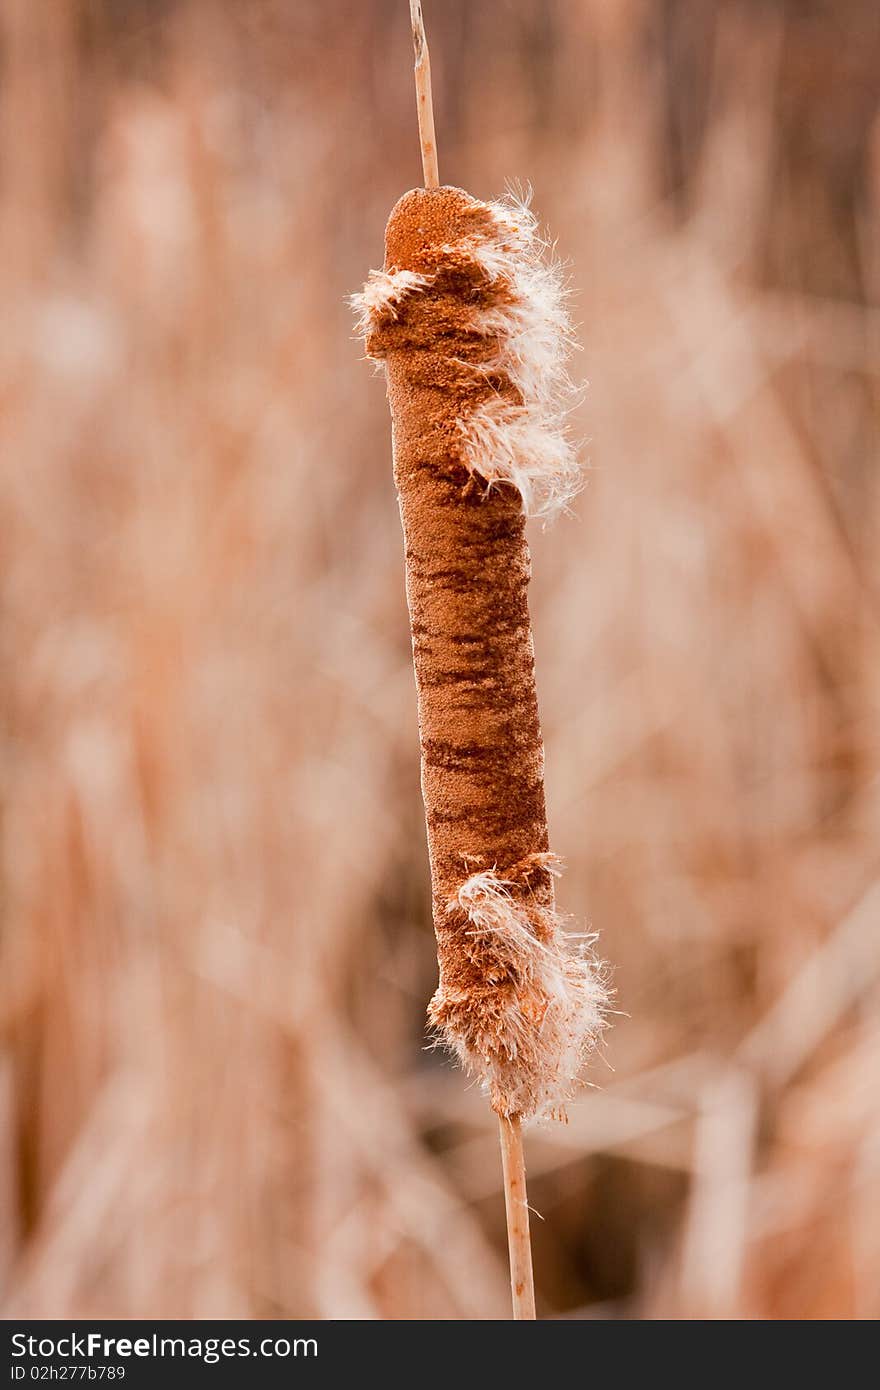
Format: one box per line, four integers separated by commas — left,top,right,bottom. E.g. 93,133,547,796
355,188,605,1115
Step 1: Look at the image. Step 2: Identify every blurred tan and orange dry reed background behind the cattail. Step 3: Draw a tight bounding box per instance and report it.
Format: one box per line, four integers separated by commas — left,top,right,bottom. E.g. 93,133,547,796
0,0,880,1319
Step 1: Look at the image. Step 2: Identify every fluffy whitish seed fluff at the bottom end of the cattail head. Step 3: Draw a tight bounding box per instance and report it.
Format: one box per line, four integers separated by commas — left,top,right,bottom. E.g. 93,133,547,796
450,870,608,1118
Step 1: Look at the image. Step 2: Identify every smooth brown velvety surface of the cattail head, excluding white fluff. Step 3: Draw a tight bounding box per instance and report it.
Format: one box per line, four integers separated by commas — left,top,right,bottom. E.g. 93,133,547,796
367,188,553,1095
